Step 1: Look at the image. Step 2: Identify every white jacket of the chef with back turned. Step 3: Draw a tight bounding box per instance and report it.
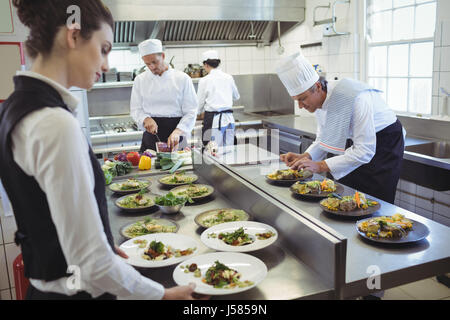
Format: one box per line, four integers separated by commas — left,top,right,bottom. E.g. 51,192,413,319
197,69,241,128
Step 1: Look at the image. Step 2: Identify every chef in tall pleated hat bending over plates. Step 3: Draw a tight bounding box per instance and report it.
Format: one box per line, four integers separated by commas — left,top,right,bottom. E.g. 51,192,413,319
277,53,404,203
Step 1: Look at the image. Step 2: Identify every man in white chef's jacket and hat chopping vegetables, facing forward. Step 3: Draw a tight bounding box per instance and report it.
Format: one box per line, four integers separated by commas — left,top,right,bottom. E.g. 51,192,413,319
130,39,198,152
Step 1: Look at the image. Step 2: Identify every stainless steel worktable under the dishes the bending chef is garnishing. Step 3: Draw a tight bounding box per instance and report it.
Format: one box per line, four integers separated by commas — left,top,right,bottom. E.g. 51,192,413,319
232,164,450,298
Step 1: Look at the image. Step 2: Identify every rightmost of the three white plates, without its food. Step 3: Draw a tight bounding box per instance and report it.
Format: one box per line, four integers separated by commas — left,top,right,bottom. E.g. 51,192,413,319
200,221,278,252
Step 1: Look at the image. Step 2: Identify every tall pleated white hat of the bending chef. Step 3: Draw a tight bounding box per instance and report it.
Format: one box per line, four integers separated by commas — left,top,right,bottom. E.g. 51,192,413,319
276,53,319,97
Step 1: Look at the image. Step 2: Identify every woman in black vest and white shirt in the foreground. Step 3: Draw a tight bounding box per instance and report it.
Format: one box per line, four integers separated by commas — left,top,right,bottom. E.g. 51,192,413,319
0,0,203,300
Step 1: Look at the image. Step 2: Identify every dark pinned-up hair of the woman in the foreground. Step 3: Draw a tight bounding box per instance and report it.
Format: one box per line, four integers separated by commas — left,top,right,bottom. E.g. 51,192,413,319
12,0,114,59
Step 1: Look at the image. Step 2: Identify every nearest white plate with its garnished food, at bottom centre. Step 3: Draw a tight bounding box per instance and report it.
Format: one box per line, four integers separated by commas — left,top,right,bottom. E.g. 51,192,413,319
173,252,267,295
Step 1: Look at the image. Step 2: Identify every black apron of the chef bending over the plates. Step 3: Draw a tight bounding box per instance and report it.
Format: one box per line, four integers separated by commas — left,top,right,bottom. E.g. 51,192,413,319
339,120,405,204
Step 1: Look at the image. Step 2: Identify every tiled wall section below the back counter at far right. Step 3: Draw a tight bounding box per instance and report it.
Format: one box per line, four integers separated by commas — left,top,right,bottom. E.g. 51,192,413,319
395,180,450,227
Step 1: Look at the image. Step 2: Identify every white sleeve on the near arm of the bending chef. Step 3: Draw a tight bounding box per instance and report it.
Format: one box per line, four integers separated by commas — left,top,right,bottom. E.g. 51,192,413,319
325,92,377,180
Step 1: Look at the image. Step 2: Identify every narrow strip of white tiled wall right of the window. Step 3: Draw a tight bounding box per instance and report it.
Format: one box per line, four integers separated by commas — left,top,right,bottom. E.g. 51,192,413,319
433,0,450,116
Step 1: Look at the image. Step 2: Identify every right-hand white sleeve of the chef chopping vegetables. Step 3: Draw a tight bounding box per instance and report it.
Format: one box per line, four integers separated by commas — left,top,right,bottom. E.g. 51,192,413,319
177,75,198,134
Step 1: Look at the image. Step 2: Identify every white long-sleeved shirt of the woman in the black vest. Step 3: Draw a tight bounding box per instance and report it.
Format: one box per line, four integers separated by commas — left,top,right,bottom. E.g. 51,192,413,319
11,71,164,299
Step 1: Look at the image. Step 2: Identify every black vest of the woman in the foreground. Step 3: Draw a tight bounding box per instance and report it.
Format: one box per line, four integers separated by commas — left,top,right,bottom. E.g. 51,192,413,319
0,76,114,281
